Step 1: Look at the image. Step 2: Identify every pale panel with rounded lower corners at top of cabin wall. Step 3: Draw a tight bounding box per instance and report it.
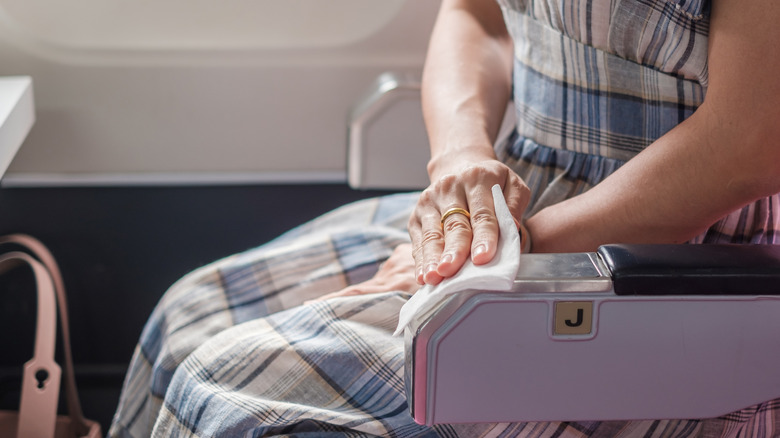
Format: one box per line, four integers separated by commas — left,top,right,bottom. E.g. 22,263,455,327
0,0,404,50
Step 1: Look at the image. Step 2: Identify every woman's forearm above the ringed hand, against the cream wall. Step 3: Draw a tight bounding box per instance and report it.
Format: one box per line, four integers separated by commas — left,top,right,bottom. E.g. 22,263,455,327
422,0,512,181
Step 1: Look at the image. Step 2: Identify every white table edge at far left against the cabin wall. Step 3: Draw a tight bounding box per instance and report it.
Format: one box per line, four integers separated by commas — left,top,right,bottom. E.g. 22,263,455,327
0,76,35,178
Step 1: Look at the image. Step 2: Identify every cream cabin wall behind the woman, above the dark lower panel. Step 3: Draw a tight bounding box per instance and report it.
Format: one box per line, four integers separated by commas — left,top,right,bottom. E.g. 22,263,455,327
0,0,438,185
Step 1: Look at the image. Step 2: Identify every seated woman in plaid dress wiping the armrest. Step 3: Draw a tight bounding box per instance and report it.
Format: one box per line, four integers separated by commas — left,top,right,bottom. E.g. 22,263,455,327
110,0,780,437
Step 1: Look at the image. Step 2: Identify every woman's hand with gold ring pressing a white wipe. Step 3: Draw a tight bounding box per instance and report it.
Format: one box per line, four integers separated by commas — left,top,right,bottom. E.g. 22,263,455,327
409,158,530,284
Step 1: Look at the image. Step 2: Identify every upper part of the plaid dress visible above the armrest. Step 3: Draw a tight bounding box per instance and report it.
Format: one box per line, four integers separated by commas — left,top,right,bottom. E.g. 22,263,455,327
496,0,780,243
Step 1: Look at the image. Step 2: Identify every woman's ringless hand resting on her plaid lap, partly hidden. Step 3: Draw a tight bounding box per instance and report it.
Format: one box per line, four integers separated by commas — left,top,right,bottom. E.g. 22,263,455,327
312,243,420,301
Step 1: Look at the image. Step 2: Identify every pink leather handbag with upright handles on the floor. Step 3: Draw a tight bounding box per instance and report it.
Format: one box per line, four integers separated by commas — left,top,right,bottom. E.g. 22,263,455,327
0,234,101,438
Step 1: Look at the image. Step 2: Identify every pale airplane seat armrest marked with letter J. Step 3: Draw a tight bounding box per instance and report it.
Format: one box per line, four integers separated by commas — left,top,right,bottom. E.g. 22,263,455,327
405,245,780,425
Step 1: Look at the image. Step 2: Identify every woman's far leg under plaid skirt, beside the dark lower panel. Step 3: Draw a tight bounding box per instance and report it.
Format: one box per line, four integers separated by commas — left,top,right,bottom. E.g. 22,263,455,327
110,194,416,437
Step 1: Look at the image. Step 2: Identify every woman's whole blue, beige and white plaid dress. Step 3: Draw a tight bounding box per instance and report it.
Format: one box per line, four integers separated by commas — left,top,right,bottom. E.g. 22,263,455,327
109,0,780,437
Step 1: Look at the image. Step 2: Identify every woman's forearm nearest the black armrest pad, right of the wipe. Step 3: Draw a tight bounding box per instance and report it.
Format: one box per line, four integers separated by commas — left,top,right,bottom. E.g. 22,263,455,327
527,105,780,252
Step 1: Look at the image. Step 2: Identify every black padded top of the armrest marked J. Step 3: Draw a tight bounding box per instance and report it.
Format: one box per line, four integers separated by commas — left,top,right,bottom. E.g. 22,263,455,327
598,244,780,295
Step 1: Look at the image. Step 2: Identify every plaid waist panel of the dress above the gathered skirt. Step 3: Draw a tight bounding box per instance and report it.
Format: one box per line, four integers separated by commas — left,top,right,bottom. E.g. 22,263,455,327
510,13,706,160
